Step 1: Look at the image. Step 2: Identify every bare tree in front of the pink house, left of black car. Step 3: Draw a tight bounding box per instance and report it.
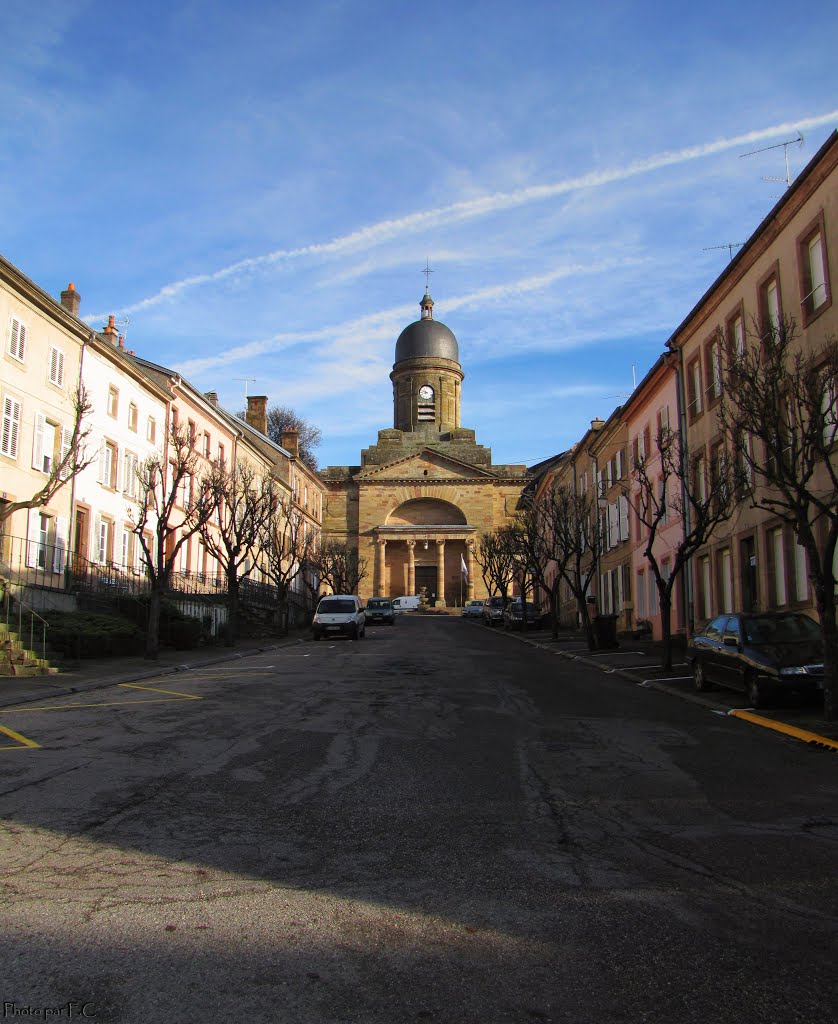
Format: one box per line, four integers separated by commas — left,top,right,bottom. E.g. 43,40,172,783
623,424,739,671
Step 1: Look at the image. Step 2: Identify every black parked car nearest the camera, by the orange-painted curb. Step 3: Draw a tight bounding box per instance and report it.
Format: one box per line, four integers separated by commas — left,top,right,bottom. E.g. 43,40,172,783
686,611,824,708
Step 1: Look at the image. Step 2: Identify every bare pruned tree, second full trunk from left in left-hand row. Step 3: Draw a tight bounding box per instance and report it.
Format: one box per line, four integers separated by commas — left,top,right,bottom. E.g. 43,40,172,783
199,462,277,647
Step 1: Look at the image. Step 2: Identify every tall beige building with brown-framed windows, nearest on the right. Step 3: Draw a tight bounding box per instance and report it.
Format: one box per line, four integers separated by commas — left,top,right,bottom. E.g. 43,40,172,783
667,133,838,623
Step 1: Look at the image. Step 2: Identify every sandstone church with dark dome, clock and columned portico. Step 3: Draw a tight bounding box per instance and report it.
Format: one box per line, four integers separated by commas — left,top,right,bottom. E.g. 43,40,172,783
320,288,527,607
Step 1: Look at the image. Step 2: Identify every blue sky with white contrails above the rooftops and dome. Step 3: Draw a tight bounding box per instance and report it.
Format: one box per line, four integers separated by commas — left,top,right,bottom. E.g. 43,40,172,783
0,0,838,466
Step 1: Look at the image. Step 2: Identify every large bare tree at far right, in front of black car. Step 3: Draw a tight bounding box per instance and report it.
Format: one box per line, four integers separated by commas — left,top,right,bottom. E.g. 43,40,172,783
718,317,838,721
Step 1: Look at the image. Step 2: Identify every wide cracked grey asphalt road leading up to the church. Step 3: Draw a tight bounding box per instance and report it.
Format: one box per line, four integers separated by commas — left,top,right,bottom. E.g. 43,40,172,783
0,616,838,1024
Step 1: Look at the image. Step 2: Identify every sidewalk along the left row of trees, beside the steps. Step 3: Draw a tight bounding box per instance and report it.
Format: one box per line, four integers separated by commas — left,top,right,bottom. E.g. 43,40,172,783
0,631,308,708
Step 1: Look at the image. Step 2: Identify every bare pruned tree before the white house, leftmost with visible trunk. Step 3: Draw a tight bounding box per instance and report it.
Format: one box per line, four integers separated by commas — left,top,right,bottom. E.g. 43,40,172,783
129,422,215,658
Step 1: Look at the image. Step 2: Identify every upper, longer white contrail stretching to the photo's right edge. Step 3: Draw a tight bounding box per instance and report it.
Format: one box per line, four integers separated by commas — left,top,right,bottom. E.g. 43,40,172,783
93,111,838,322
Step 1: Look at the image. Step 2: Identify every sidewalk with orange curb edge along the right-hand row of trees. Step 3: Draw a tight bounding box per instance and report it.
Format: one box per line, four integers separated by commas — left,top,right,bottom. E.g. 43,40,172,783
499,618,838,743
